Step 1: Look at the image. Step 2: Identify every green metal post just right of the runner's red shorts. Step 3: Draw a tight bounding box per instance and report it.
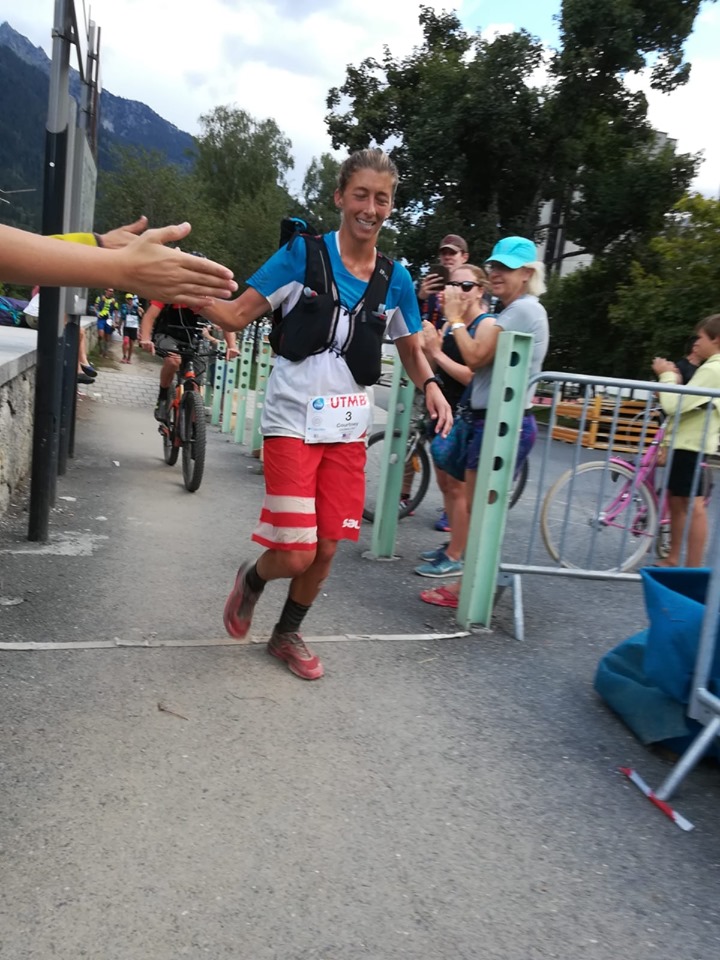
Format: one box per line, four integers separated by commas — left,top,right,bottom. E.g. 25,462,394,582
369,359,415,560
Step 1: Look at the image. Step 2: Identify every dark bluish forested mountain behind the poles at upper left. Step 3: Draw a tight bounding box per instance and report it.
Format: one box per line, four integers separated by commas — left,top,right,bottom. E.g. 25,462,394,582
0,22,194,231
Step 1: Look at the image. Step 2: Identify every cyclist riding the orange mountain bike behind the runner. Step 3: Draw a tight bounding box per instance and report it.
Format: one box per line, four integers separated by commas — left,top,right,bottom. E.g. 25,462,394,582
140,254,239,423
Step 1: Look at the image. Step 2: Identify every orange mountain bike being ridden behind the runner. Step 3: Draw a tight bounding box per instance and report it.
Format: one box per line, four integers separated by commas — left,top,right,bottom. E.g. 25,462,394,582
155,325,217,493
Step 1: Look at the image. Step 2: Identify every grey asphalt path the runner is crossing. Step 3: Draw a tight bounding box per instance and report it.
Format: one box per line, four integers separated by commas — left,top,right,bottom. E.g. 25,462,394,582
0,394,720,960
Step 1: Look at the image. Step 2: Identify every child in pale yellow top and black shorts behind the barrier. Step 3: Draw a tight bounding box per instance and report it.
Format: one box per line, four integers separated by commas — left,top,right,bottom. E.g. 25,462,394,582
652,314,720,567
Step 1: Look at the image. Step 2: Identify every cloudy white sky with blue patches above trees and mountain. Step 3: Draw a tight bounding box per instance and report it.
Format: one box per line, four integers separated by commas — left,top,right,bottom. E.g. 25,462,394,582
9,0,720,197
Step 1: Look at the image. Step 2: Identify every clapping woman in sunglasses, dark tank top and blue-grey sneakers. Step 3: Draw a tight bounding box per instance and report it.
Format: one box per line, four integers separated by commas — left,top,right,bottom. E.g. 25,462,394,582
415,263,495,577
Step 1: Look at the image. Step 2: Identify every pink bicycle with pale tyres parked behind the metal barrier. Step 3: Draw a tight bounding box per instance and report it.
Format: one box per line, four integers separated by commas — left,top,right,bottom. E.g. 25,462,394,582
540,424,713,572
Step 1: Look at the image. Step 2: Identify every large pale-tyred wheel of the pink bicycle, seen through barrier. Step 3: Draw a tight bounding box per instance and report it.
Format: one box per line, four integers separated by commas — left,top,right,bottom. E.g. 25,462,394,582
540,461,657,571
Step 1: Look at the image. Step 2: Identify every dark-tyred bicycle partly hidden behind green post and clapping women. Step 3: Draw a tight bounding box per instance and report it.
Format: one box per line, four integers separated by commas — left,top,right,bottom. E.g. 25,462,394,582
363,409,529,523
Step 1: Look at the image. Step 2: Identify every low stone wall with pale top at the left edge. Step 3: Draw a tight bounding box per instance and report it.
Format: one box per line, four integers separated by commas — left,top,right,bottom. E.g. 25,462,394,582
0,317,97,516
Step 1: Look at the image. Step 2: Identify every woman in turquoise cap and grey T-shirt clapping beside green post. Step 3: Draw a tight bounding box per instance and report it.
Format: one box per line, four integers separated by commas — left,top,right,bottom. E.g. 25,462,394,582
420,237,550,607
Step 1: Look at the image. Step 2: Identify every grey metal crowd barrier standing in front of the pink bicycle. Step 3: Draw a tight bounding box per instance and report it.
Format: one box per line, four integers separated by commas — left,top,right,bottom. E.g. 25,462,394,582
500,372,720,639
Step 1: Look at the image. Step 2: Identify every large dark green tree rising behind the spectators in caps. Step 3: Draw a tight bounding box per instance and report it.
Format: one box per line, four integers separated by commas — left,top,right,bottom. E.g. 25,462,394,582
327,0,699,278
